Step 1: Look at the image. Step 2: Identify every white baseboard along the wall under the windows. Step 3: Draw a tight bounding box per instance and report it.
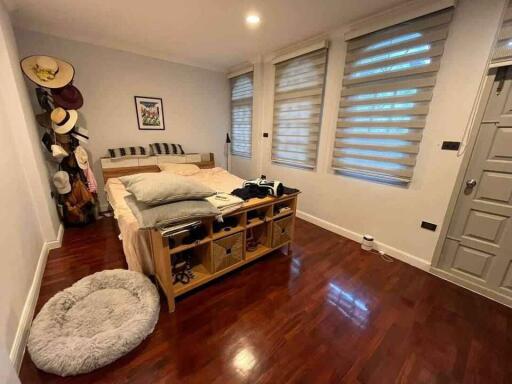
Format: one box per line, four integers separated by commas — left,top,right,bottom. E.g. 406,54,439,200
297,210,430,272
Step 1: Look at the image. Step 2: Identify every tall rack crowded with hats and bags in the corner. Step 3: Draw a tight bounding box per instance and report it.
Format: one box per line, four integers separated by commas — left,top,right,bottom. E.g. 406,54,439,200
20,56,99,226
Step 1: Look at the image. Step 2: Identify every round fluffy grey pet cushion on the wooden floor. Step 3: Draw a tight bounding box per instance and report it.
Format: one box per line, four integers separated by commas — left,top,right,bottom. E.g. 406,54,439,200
27,269,160,376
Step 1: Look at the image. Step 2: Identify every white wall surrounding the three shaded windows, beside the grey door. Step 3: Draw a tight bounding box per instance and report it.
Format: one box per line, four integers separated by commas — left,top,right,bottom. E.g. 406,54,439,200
239,0,504,269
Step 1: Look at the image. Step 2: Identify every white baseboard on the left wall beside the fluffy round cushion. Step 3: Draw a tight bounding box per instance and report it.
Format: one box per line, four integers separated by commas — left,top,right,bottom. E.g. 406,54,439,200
10,224,64,372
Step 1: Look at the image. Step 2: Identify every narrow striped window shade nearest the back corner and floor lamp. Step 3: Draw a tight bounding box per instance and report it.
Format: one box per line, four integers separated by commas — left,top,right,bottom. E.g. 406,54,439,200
230,72,253,157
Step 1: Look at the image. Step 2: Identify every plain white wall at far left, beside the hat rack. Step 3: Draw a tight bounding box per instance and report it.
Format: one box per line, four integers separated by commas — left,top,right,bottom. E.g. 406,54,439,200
0,0,60,368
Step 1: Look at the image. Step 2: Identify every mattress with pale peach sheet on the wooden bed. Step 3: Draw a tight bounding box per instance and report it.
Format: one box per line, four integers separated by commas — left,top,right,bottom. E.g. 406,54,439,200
105,167,244,275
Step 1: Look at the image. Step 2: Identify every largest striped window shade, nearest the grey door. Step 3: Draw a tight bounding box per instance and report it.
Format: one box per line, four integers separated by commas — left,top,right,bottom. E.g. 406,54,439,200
333,8,452,183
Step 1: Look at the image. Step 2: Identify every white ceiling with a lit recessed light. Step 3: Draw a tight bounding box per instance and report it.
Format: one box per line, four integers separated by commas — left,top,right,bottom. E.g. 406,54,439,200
7,0,404,71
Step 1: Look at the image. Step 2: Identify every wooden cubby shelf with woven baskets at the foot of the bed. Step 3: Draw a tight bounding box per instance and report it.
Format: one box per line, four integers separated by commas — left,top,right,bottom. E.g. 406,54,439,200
151,193,298,312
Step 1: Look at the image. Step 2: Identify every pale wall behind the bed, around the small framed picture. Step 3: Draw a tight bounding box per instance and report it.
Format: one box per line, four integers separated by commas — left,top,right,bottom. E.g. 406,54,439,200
16,30,229,210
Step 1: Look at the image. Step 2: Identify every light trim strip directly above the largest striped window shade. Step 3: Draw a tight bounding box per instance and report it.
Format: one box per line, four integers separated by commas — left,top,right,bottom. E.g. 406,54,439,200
345,0,456,40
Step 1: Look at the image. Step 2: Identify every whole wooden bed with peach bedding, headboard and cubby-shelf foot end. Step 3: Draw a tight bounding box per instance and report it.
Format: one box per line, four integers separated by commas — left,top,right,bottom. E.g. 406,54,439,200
102,154,300,312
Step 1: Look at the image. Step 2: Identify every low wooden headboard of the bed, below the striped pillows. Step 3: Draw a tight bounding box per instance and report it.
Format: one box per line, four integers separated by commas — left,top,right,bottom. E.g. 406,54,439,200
101,153,215,183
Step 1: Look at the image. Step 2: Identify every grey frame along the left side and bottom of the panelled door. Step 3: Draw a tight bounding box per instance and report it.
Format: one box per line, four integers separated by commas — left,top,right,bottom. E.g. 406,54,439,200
429,67,512,307
